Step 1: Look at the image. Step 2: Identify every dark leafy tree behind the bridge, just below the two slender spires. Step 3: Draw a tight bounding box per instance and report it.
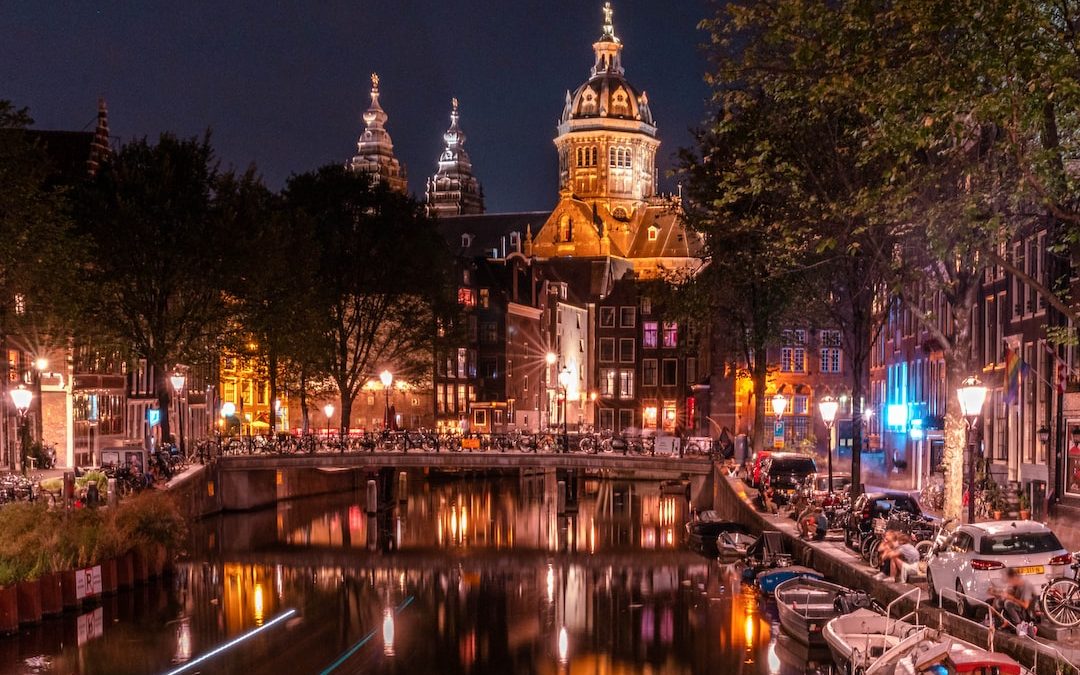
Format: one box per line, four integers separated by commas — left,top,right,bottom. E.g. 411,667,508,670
284,165,453,434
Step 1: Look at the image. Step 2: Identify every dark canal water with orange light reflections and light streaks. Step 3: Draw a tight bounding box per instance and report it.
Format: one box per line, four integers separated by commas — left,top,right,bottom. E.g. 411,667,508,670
0,471,827,675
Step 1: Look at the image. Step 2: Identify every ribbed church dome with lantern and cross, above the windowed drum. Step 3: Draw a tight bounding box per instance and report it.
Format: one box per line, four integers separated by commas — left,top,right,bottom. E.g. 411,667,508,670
561,2,653,126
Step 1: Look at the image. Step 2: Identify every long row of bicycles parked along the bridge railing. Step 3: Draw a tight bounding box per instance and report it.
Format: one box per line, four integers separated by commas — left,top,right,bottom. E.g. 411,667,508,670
207,429,713,457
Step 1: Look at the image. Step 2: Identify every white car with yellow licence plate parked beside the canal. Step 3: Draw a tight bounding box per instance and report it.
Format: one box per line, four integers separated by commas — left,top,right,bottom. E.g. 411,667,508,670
927,521,1071,617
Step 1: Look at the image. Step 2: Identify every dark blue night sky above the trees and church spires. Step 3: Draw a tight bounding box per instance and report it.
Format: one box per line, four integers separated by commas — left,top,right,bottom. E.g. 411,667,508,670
0,0,707,213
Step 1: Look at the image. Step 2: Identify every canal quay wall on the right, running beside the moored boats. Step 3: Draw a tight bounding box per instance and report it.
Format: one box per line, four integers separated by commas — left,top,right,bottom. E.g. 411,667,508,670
713,469,1077,675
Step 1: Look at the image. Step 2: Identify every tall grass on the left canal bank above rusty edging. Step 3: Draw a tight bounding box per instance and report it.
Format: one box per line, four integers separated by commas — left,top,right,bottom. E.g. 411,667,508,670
0,490,186,586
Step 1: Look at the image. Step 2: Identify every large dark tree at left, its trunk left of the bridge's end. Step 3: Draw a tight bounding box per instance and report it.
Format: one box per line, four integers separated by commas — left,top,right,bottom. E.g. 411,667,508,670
79,134,243,438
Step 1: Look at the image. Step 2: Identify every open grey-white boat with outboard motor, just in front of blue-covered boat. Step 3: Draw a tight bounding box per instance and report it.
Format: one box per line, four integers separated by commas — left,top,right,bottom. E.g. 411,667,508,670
775,576,874,645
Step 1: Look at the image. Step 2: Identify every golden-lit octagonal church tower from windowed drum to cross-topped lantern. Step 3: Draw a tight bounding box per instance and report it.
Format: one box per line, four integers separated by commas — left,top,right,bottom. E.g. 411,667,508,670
555,2,660,211
